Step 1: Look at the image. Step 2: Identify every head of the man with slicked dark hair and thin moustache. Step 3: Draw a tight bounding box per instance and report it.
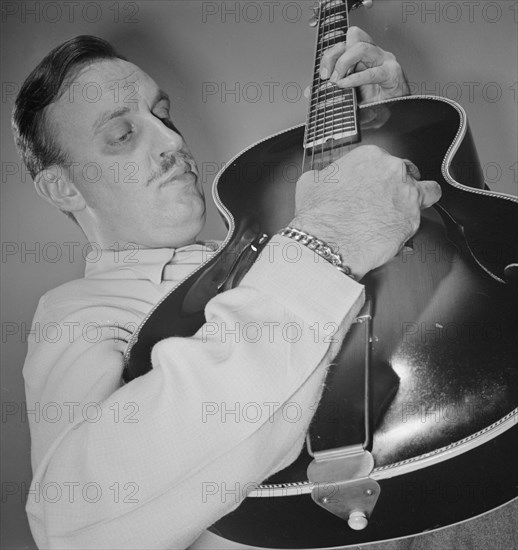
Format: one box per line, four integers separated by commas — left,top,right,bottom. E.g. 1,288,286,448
13,36,205,248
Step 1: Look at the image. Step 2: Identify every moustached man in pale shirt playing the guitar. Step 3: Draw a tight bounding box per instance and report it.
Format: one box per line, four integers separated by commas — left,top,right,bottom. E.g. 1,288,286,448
13,28,440,548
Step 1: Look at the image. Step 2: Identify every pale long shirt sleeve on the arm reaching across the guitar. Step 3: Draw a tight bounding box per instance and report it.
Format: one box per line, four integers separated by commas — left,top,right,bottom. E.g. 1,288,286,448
24,237,364,549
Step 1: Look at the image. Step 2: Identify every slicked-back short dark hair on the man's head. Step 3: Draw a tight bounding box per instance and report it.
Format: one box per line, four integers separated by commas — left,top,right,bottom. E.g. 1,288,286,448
12,35,126,222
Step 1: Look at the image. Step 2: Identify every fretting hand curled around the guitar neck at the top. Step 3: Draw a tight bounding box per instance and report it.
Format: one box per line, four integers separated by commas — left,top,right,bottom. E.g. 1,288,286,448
320,27,410,103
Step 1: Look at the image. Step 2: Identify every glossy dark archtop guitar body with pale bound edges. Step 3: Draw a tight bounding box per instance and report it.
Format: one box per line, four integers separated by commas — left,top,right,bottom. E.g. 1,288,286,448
126,96,518,548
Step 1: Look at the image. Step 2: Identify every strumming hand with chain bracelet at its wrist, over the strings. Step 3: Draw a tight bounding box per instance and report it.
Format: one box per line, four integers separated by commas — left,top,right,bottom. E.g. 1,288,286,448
290,145,441,279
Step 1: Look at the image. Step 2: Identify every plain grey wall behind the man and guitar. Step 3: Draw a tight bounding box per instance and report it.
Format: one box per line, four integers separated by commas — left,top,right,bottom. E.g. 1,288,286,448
0,0,518,549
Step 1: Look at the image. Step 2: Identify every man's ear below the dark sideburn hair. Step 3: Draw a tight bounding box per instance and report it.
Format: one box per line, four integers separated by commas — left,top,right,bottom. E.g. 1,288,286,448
34,165,86,212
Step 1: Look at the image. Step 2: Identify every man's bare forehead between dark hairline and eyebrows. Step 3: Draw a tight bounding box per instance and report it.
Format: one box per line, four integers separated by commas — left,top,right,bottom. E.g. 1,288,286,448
48,59,158,128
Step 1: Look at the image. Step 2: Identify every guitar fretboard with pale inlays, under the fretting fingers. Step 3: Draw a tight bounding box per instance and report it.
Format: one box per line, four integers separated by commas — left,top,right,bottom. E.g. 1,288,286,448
304,0,358,154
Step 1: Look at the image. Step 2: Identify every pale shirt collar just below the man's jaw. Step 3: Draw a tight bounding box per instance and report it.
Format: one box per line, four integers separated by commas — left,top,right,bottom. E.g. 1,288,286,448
85,243,218,284
